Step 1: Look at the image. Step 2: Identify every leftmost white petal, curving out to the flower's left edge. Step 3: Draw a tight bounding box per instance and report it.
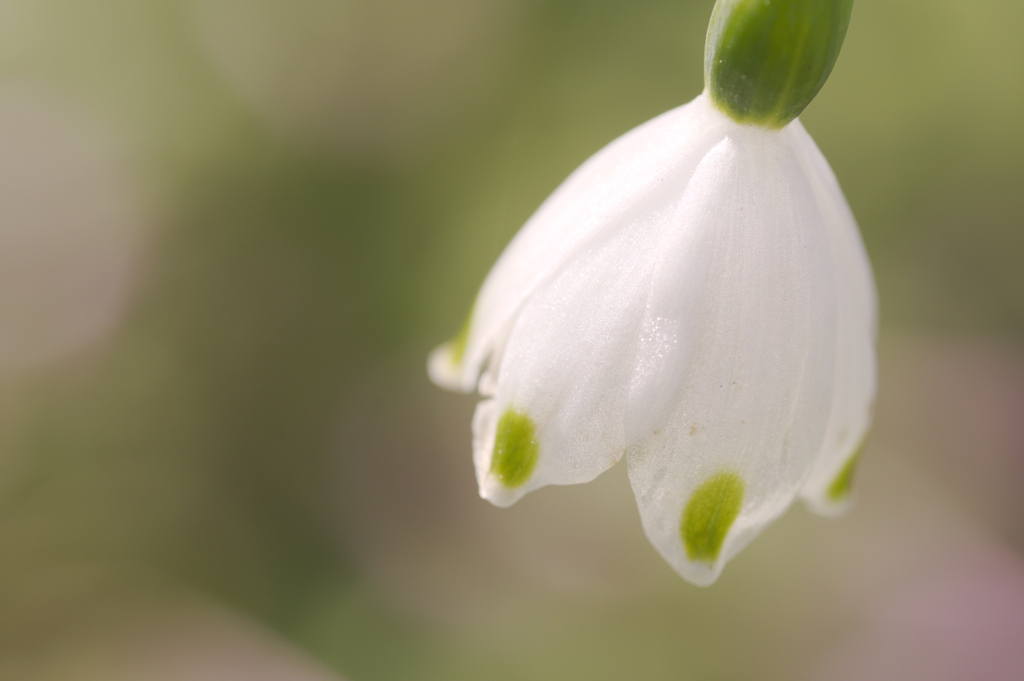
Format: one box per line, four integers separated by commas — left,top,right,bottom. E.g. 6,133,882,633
431,95,723,394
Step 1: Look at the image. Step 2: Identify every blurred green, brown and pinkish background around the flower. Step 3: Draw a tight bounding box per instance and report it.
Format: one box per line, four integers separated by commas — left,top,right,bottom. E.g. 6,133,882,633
0,0,1024,681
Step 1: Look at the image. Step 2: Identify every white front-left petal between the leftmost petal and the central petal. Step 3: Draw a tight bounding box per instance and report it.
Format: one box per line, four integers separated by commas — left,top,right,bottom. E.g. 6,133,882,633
474,207,673,506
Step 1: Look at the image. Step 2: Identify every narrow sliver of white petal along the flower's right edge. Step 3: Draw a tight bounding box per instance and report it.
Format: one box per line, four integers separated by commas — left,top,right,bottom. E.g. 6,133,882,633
783,122,878,515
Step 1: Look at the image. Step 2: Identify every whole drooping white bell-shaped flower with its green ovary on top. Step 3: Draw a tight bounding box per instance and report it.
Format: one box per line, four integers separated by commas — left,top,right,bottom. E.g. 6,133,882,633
429,0,876,585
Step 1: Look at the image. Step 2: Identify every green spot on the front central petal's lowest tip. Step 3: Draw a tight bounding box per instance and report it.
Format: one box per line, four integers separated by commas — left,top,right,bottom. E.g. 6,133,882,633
679,471,745,563
